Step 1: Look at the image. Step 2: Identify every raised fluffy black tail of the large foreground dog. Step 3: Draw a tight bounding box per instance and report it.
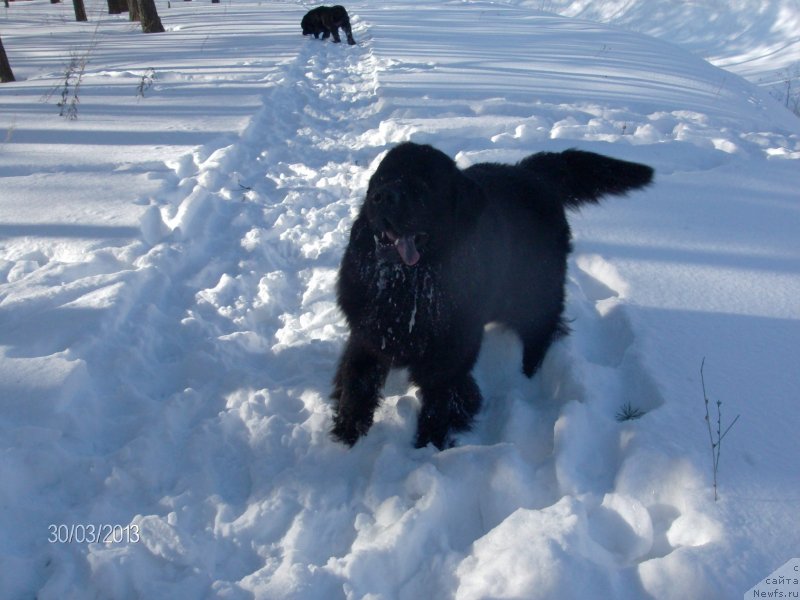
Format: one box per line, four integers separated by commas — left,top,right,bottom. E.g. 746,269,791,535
519,149,653,208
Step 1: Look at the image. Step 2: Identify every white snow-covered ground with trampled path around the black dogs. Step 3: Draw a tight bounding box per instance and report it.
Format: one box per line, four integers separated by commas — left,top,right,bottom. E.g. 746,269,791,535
0,0,800,600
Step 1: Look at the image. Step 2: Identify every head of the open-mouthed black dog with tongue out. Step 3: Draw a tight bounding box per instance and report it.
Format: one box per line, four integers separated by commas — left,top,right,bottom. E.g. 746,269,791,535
363,142,482,266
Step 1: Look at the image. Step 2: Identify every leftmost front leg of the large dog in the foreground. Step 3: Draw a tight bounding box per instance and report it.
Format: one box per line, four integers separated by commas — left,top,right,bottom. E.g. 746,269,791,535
331,337,389,446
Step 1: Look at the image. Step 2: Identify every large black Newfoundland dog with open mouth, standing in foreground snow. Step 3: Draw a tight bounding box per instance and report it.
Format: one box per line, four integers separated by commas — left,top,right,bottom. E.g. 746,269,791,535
332,143,653,448
